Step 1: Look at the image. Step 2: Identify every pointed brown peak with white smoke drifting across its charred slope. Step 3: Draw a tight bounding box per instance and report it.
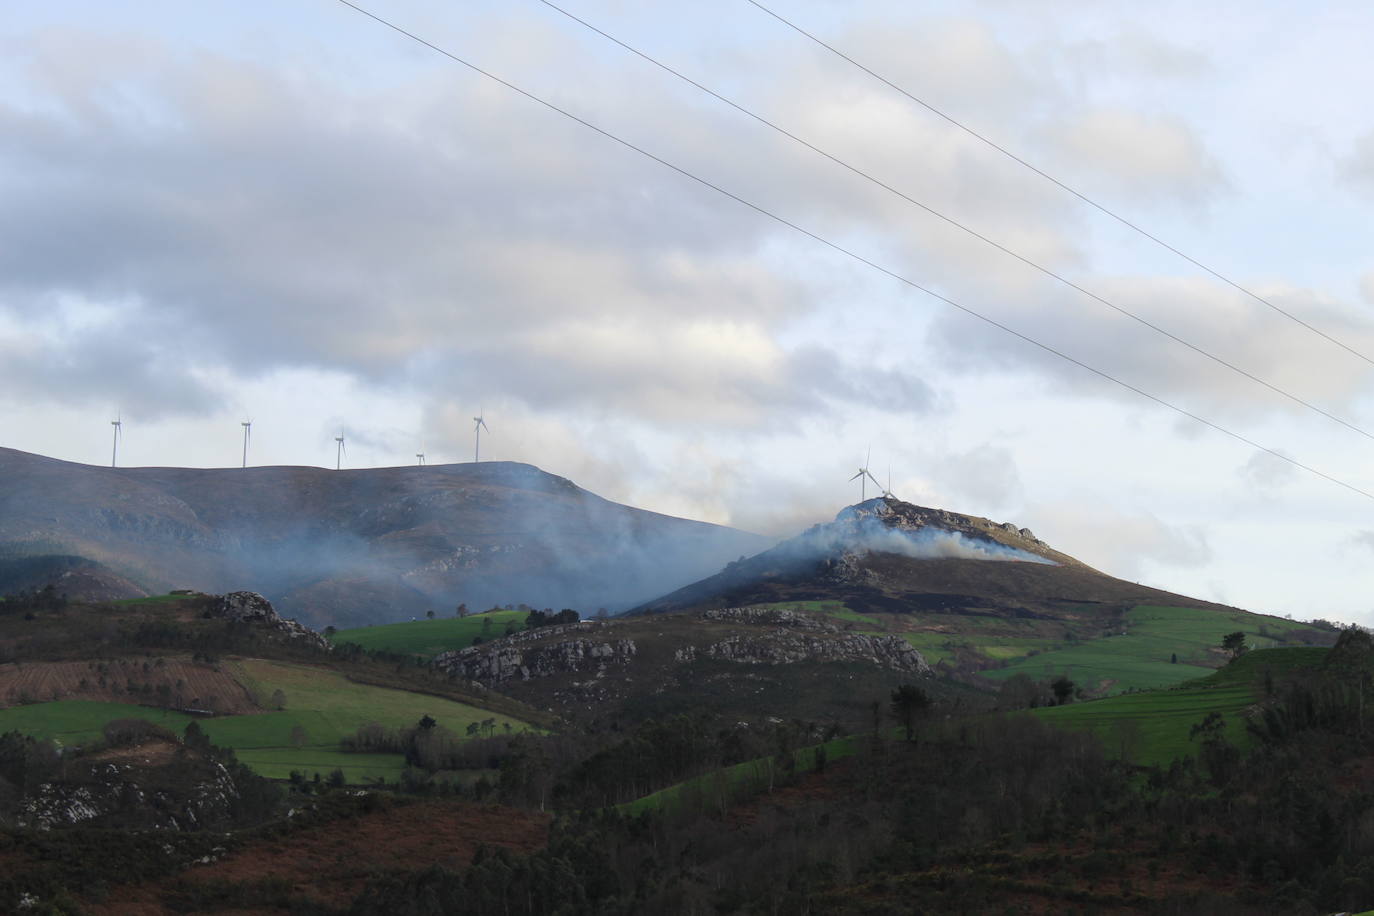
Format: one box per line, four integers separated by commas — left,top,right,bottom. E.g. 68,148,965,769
632,497,1232,619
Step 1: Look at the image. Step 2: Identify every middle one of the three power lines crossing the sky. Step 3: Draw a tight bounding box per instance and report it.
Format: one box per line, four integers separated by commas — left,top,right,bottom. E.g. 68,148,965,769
539,0,1374,441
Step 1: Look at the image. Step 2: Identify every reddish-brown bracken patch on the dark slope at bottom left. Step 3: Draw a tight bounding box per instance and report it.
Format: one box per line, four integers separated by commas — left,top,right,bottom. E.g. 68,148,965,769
85,801,551,916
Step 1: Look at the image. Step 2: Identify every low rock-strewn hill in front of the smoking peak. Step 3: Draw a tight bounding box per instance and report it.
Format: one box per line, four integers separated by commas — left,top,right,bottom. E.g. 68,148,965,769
434,607,932,726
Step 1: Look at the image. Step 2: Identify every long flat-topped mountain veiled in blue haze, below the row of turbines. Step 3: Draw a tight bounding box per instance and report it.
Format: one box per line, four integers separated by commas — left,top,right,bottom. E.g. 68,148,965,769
0,449,772,625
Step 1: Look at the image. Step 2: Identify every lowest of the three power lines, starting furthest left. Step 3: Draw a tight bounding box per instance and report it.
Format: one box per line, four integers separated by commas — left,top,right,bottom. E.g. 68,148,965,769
338,0,1374,500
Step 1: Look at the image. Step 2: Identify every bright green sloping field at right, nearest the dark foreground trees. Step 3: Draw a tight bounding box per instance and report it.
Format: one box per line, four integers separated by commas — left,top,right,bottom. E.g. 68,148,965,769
1033,648,1327,766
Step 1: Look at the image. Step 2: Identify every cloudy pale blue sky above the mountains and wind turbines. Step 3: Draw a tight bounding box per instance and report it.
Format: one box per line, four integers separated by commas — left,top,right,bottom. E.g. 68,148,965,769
0,0,1374,623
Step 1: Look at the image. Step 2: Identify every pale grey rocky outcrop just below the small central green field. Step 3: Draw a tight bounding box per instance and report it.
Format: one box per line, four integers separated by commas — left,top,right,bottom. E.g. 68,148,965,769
434,623,638,684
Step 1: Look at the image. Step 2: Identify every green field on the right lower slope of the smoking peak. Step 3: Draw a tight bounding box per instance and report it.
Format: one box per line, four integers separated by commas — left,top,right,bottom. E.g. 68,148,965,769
973,606,1305,694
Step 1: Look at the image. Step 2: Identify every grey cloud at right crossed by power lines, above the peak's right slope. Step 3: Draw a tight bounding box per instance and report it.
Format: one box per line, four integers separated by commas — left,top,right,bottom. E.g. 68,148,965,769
933,276,1374,419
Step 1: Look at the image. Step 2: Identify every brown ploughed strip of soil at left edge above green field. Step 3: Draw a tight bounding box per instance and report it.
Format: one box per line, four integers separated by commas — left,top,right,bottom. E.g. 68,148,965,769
0,656,259,714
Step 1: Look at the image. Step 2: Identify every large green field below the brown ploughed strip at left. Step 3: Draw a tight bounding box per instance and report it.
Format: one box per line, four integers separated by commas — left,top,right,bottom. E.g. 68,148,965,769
0,659,528,783
